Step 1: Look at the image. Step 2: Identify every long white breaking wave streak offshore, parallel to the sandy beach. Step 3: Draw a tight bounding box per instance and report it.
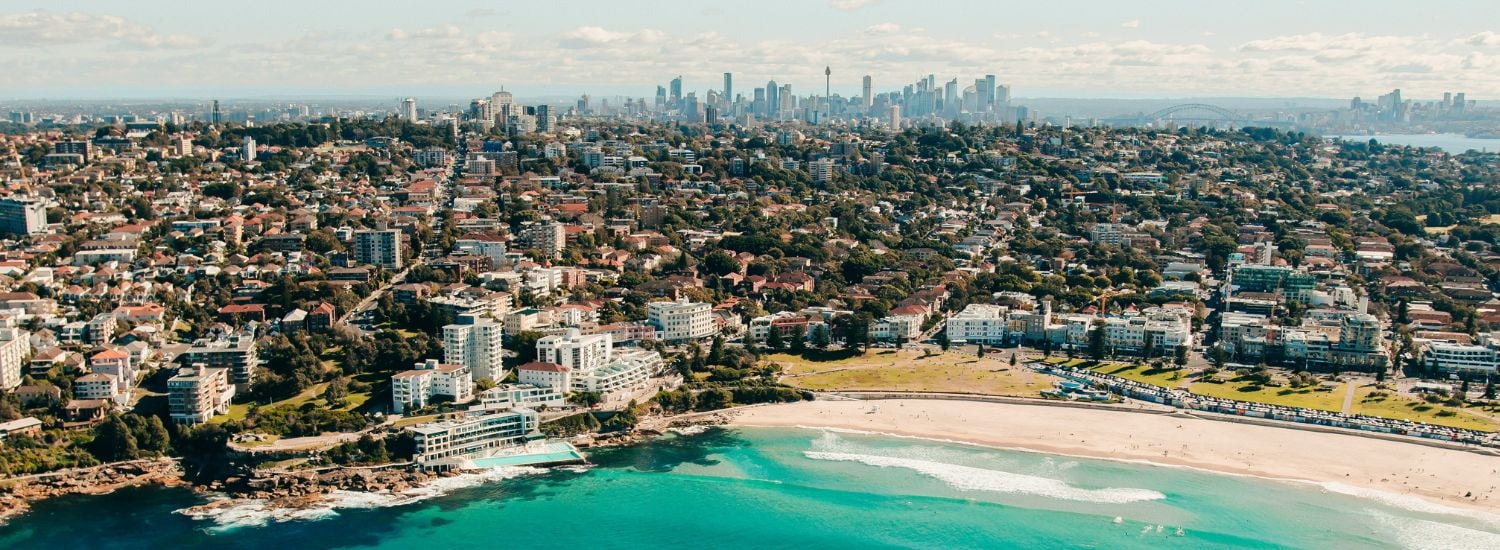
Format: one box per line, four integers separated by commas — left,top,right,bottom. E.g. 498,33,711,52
804,451,1167,504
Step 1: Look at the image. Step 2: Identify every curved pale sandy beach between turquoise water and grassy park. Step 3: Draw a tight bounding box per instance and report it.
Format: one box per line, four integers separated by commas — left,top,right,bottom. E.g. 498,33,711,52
731,400,1500,514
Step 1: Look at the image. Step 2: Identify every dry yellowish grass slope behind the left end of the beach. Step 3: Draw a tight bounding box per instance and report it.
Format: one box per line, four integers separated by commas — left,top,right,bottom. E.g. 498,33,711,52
770,349,1053,396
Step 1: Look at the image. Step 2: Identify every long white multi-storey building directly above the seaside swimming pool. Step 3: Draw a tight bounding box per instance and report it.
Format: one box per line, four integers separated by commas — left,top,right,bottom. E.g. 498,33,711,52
407,408,542,465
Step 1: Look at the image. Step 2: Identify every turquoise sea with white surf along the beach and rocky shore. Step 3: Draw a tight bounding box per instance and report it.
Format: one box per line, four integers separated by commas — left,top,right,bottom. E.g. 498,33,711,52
0,429,1500,549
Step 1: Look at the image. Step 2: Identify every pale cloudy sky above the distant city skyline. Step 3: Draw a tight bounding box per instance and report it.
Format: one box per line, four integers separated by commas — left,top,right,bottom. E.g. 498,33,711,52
0,0,1500,99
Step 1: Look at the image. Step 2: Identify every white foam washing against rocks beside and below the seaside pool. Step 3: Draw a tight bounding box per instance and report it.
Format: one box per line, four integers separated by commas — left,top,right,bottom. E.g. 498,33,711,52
177,466,545,531
